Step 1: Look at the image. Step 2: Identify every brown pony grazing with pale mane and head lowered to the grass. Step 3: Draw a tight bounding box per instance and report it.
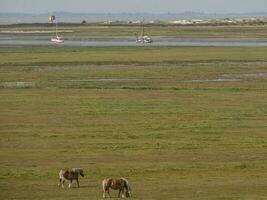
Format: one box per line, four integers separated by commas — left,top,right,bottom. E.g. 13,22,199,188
102,178,131,198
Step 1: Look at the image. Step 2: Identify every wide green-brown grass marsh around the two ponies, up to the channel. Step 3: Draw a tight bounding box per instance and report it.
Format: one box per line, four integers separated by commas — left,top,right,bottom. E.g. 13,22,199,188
0,47,267,200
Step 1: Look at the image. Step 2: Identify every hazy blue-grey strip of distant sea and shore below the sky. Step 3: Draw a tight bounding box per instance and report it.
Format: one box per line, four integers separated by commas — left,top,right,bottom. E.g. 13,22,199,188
0,12,267,24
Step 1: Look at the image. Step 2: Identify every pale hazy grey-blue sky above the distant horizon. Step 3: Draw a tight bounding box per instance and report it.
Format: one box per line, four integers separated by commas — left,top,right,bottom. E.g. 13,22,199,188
0,0,267,13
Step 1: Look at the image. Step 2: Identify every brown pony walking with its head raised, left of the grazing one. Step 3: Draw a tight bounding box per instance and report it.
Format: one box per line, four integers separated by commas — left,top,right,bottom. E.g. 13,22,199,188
58,168,84,188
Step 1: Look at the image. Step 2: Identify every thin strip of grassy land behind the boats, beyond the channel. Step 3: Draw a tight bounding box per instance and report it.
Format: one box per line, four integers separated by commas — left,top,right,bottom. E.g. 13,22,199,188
0,24,267,40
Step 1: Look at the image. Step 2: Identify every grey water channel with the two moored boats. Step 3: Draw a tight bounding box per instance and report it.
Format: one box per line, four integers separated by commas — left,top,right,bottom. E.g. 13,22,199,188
0,34,267,47
